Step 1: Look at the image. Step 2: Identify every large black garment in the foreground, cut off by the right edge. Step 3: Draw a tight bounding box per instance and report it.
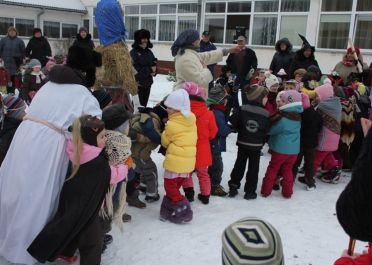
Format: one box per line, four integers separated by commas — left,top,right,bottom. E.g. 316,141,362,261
336,129,372,242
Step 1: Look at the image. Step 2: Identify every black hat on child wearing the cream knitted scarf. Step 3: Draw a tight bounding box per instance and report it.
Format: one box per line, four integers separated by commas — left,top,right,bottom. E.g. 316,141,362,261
102,104,131,130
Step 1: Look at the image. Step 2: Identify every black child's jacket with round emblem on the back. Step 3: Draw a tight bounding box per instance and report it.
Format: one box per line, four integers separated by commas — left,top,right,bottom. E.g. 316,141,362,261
230,101,270,150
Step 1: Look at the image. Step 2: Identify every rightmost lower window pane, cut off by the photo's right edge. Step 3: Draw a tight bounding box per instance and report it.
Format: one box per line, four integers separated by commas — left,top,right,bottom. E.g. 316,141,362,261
354,15,372,49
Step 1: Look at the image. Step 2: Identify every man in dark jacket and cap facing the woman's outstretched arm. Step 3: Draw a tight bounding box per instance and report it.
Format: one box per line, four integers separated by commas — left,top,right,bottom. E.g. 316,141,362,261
226,36,257,108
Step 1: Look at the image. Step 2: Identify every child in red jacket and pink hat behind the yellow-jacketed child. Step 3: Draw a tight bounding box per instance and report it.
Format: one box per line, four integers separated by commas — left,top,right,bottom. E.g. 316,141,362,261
183,82,218,204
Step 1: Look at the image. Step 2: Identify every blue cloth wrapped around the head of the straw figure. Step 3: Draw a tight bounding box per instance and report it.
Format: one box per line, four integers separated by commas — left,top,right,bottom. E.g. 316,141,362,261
95,0,127,46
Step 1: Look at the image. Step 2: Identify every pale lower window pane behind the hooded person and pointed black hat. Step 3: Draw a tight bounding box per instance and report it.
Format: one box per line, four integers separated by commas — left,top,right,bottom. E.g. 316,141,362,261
279,16,307,46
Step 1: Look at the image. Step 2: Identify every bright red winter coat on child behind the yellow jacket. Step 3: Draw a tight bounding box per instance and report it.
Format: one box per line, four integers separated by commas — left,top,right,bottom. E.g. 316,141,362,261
190,99,218,168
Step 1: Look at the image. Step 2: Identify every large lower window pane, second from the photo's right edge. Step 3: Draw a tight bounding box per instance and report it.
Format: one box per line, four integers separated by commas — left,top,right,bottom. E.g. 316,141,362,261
318,15,350,49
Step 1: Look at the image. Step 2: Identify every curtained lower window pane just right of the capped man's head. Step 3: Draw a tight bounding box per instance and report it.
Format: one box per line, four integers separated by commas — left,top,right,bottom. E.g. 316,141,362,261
252,15,278,46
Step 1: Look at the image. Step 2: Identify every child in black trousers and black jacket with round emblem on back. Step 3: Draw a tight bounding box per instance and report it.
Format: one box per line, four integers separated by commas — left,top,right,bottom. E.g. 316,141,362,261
229,86,270,200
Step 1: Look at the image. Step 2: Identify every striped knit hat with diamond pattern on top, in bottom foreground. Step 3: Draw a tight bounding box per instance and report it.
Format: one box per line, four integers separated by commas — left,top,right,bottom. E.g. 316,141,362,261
222,218,284,265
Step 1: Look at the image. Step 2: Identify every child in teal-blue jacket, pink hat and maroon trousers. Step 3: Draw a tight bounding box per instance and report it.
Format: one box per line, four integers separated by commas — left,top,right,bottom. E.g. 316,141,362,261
261,90,303,199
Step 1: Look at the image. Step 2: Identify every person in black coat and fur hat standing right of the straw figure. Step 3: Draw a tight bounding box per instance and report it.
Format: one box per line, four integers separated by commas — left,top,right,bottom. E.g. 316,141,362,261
130,29,157,107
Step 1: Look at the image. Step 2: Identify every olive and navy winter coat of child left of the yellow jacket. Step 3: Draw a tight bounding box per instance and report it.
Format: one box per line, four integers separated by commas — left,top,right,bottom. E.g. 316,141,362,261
130,109,163,161
